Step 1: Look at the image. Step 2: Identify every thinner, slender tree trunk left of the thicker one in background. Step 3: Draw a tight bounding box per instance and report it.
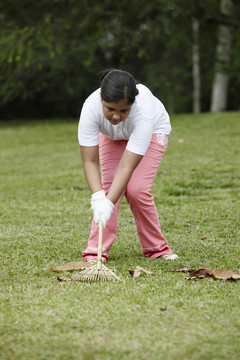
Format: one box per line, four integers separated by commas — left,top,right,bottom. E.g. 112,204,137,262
192,18,201,114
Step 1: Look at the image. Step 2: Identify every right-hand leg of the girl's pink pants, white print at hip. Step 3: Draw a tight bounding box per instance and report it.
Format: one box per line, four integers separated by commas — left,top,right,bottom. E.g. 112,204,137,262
125,134,172,258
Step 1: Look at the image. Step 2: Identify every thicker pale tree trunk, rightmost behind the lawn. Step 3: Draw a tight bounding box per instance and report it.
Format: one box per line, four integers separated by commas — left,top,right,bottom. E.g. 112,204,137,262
210,0,233,112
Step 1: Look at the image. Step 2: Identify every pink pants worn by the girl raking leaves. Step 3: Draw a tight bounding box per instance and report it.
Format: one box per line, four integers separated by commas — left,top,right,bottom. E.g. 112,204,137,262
82,134,172,261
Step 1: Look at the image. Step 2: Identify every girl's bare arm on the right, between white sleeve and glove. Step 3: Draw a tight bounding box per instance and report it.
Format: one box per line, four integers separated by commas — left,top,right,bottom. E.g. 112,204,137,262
107,150,143,204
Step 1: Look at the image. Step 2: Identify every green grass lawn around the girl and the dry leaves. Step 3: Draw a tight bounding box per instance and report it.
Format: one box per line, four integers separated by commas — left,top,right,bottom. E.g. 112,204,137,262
0,113,240,360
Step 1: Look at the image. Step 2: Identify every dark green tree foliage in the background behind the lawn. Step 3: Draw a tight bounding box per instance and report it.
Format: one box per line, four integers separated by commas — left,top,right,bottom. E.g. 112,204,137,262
0,0,240,118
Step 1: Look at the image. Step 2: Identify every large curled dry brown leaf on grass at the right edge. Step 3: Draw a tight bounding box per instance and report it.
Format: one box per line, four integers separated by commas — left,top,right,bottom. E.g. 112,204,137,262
186,269,240,280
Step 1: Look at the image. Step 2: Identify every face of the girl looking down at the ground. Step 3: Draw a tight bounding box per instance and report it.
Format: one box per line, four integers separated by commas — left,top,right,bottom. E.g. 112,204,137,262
102,100,131,125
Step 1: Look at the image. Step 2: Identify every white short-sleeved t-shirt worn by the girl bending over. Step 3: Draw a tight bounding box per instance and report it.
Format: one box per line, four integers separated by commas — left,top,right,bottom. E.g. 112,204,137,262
78,84,171,155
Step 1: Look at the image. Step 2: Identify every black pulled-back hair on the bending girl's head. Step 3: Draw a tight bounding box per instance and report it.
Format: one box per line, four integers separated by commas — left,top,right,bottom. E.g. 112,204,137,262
101,69,138,105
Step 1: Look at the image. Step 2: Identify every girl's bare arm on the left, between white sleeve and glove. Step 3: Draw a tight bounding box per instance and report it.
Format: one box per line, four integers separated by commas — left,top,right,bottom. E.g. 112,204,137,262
80,145,103,194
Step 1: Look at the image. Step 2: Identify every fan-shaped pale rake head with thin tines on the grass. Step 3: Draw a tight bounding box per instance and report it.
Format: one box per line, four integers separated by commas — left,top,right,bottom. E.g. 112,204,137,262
72,264,122,282
